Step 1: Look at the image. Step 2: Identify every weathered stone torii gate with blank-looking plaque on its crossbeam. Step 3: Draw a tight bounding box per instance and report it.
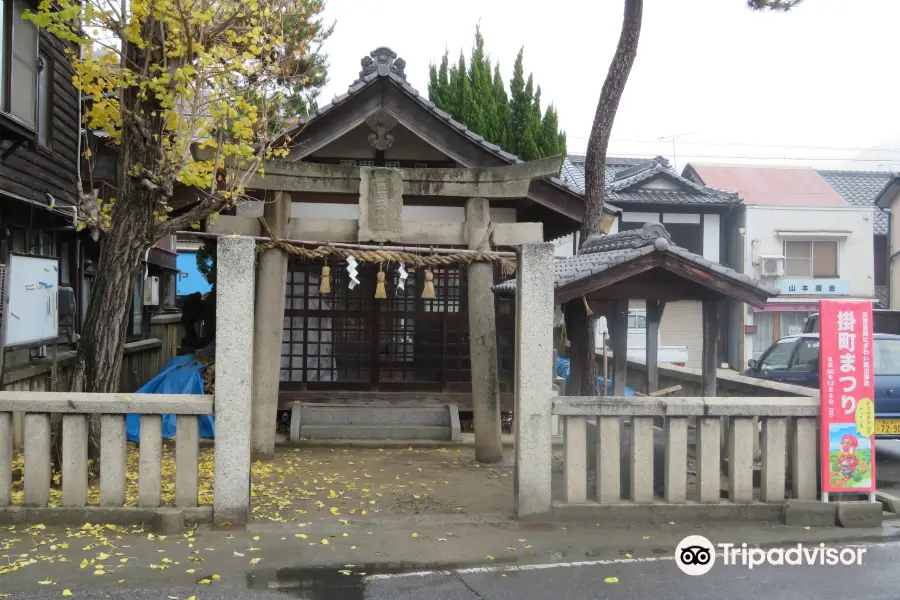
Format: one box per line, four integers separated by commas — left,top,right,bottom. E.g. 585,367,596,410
208,156,560,462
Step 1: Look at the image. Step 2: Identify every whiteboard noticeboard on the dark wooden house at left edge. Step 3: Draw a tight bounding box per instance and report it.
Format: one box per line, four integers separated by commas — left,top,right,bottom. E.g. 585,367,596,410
3,254,59,347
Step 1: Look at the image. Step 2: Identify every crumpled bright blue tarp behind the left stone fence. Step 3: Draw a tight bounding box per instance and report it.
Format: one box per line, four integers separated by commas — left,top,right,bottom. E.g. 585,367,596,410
125,356,215,442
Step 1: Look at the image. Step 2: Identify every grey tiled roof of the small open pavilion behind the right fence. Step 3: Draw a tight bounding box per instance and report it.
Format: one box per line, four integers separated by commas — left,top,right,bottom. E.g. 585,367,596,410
493,223,778,296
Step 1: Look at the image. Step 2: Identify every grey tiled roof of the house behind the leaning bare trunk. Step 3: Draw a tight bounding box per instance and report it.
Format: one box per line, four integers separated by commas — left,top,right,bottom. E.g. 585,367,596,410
561,154,741,206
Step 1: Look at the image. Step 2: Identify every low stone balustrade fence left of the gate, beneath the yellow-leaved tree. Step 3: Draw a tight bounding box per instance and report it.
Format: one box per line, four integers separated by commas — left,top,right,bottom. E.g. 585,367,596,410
0,392,213,508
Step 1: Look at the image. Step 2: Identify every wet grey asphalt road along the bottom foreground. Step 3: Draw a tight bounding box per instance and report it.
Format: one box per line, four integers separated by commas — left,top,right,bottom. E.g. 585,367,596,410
8,542,900,600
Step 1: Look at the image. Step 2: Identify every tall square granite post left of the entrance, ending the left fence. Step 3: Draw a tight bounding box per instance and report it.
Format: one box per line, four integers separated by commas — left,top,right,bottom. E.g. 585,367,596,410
213,237,258,524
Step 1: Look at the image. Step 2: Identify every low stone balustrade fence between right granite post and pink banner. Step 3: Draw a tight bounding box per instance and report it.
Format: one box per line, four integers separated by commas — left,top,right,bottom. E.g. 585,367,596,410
552,397,819,504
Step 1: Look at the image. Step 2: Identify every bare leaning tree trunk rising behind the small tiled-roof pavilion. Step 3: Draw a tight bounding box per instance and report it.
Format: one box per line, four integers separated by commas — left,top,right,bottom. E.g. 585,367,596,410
568,0,644,395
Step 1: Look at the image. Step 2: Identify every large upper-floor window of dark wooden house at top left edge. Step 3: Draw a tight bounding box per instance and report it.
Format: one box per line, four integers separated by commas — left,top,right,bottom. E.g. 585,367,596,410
0,0,38,130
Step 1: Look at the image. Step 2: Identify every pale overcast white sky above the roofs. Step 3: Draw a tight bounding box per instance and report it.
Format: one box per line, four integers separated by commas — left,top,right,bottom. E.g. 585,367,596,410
322,0,900,171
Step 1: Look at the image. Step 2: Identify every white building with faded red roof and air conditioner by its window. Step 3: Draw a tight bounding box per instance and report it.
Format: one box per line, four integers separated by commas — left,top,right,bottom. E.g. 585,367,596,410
685,163,875,367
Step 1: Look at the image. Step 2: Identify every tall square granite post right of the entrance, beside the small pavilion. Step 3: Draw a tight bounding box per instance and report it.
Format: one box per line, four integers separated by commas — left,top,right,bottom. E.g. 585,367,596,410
514,243,553,518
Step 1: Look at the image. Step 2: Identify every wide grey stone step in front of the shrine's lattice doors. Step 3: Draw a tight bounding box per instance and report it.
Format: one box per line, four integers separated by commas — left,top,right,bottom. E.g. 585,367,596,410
291,403,462,442
